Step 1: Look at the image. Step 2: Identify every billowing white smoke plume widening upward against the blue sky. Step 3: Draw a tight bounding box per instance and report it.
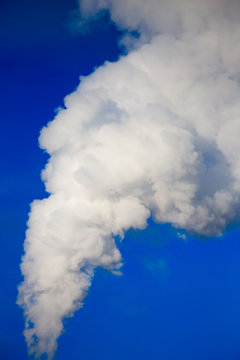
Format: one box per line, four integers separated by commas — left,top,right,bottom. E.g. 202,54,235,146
18,0,240,358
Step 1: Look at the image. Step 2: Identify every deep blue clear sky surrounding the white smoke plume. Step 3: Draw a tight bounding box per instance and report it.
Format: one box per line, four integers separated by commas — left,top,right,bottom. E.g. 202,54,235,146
0,0,240,360
